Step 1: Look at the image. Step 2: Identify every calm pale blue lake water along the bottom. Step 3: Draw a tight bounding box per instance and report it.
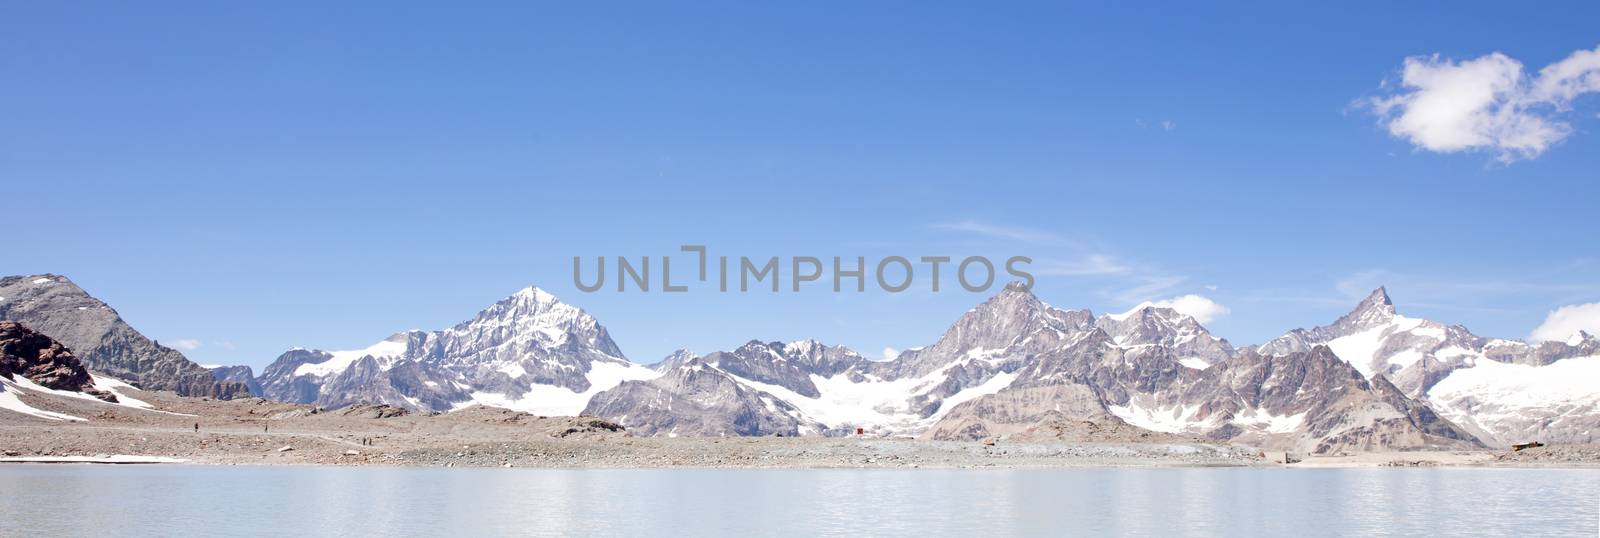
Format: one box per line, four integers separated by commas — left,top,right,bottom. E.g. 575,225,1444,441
0,464,1600,536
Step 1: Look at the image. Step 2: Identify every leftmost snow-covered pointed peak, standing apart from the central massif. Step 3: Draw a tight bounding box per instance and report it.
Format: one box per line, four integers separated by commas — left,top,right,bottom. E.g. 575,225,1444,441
258,287,658,415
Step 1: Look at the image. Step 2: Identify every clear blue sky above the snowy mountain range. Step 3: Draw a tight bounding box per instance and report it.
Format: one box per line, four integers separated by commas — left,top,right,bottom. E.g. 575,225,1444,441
0,2,1600,367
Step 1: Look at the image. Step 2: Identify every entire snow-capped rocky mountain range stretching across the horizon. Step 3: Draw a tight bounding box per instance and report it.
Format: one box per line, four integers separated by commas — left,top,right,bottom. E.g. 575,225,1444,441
0,270,1600,453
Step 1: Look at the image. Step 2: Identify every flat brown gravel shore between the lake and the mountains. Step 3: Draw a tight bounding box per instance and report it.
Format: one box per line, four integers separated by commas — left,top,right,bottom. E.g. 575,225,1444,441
0,384,1600,469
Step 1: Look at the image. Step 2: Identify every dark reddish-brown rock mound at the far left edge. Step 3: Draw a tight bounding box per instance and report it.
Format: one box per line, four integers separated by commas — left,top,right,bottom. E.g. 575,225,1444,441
0,322,117,402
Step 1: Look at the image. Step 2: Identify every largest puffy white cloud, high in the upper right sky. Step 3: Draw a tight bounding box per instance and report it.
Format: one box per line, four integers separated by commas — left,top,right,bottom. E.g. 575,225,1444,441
1362,48,1600,162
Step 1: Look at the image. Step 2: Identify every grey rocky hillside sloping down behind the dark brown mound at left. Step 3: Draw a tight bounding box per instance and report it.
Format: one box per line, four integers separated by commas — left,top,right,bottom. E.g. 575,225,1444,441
0,274,250,399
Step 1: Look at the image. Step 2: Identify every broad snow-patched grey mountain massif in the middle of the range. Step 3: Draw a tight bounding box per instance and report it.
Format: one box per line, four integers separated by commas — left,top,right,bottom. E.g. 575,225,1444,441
586,285,1232,436
